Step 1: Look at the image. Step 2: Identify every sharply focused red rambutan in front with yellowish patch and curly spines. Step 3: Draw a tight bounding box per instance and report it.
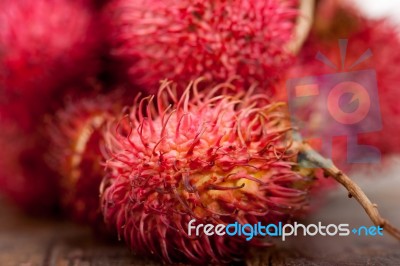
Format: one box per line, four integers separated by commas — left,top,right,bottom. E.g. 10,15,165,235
102,82,314,264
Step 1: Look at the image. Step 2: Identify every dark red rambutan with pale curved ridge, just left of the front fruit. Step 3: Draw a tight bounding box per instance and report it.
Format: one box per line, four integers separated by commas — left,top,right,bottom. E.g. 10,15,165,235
47,91,123,225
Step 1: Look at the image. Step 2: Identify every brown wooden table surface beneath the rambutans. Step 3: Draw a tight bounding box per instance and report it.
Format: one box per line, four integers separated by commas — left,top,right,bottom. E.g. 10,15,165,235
0,159,400,266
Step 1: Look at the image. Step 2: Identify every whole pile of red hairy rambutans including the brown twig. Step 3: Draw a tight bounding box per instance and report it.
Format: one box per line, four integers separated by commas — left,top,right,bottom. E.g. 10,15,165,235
0,0,400,264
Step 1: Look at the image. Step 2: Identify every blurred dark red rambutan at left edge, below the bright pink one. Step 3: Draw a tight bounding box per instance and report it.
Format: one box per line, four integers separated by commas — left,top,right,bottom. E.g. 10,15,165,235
0,120,59,214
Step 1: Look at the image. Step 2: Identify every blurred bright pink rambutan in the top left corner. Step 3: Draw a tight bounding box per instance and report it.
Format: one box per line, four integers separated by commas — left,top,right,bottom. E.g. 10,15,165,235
0,0,102,104
